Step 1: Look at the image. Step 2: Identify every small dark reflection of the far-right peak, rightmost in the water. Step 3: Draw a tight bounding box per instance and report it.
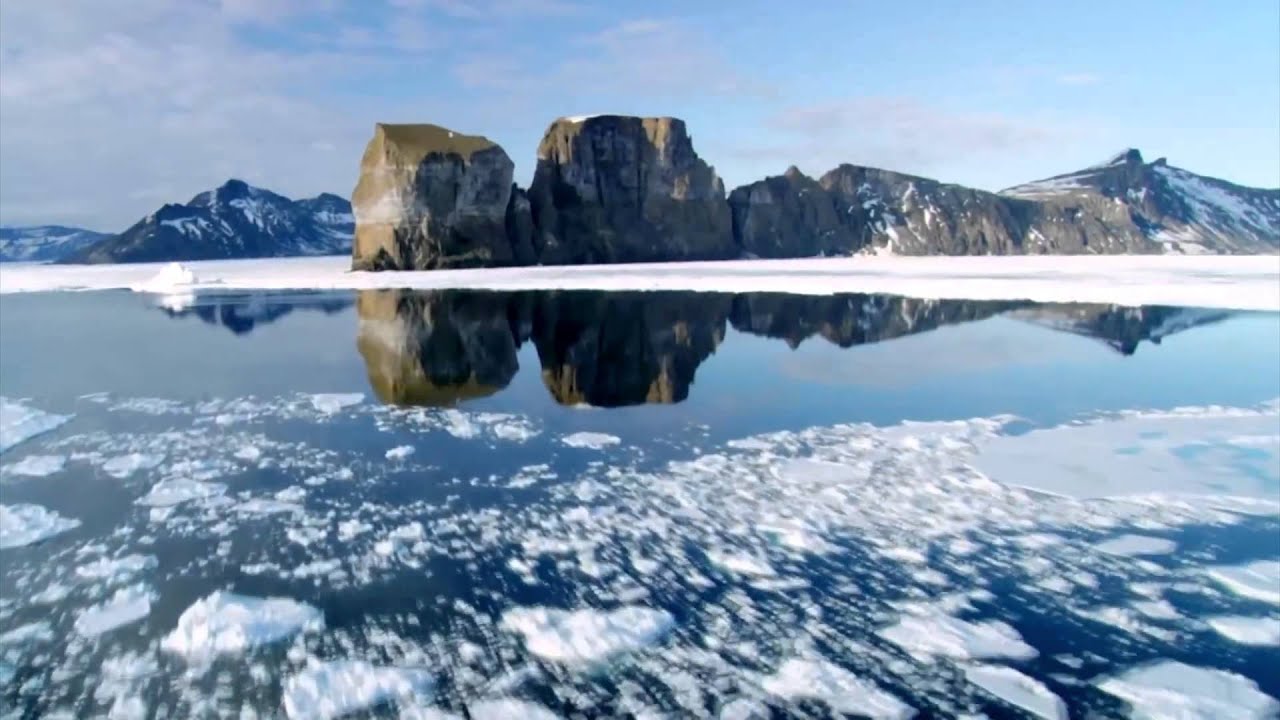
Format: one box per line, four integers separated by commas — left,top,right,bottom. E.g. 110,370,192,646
1010,304,1231,355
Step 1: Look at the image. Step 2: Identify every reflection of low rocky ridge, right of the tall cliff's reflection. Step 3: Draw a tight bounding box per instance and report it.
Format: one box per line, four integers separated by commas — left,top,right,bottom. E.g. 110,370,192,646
731,292,1024,348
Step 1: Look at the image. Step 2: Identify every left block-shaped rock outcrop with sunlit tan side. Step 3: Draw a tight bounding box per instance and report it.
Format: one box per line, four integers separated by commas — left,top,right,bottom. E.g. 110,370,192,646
352,123,519,270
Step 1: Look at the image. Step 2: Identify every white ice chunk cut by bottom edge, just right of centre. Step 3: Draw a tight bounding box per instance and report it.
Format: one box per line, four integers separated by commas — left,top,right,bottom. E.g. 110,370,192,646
760,657,915,720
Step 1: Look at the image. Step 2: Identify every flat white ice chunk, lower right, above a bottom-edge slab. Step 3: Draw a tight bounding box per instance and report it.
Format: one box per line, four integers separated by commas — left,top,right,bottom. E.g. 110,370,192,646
879,612,1037,660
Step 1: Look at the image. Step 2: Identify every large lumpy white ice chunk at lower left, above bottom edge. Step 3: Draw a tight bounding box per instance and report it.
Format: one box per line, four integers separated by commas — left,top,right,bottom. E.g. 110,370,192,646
160,591,324,662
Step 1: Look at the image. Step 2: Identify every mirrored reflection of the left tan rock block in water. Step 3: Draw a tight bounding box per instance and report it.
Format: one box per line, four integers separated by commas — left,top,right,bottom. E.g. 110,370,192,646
356,290,522,405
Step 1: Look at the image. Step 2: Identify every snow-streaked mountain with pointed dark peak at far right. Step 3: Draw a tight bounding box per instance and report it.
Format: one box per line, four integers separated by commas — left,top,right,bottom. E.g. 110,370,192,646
1002,149,1280,254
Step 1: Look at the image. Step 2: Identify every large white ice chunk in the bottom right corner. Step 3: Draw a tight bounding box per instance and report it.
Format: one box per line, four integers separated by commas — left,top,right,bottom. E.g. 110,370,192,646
1098,660,1280,720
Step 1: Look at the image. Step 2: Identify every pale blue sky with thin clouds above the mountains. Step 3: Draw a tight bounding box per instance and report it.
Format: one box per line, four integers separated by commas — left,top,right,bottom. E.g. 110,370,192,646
0,0,1280,231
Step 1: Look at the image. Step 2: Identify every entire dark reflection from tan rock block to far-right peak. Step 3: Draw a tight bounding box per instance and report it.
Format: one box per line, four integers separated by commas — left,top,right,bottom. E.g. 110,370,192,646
357,290,1228,407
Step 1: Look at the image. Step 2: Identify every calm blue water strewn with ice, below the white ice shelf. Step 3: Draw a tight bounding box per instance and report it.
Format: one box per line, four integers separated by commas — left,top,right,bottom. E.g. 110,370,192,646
0,291,1280,720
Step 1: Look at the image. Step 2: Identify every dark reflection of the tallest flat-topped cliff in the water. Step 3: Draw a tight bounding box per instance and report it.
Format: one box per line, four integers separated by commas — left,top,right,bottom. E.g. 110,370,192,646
532,292,730,407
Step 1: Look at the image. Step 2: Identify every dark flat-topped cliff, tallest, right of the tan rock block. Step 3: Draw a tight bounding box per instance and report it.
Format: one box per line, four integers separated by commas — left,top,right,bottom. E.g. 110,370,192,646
529,115,739,264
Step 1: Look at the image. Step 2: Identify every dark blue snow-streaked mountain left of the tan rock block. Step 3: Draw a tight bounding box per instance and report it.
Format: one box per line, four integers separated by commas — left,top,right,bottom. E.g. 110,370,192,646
61,179,355,263
